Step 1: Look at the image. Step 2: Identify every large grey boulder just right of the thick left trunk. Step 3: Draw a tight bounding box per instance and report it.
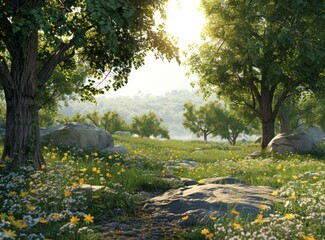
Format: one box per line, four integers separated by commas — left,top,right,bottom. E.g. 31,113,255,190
41,122,114,150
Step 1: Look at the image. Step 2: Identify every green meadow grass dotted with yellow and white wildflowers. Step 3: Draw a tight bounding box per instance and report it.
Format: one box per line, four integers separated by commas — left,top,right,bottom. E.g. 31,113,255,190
0,136,325,240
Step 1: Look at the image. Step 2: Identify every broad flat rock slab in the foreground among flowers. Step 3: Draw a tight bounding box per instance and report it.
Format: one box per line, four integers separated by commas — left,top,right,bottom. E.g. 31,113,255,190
144,179,280,225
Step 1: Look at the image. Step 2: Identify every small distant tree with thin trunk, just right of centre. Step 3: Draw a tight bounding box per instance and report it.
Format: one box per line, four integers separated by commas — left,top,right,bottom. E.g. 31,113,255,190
183,102,218,142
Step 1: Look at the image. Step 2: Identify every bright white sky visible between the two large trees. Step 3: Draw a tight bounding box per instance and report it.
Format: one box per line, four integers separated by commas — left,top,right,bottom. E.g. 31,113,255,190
105,0,204,97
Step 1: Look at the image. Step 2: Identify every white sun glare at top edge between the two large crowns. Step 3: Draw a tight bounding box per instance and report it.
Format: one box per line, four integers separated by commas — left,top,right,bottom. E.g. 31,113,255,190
166,0,205,50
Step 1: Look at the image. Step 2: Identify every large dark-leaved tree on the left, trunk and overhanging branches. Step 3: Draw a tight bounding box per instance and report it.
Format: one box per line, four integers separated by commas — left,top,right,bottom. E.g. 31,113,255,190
0,0,177,169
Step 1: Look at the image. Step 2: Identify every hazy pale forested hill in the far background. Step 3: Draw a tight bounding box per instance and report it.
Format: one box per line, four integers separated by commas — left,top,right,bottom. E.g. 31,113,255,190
60,90,213,140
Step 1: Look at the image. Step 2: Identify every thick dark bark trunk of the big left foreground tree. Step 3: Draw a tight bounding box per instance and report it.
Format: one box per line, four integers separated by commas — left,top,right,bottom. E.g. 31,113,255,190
1,32,45,169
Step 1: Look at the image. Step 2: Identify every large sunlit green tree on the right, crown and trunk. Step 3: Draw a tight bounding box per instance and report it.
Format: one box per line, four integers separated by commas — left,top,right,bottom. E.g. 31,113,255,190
188,0,325,149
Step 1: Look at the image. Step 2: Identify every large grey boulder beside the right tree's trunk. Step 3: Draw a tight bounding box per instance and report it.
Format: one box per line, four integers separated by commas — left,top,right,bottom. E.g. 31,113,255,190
267,125,325,153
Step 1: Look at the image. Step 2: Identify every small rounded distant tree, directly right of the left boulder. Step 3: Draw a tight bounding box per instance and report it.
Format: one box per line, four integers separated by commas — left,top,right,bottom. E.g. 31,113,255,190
131,111,170,139
